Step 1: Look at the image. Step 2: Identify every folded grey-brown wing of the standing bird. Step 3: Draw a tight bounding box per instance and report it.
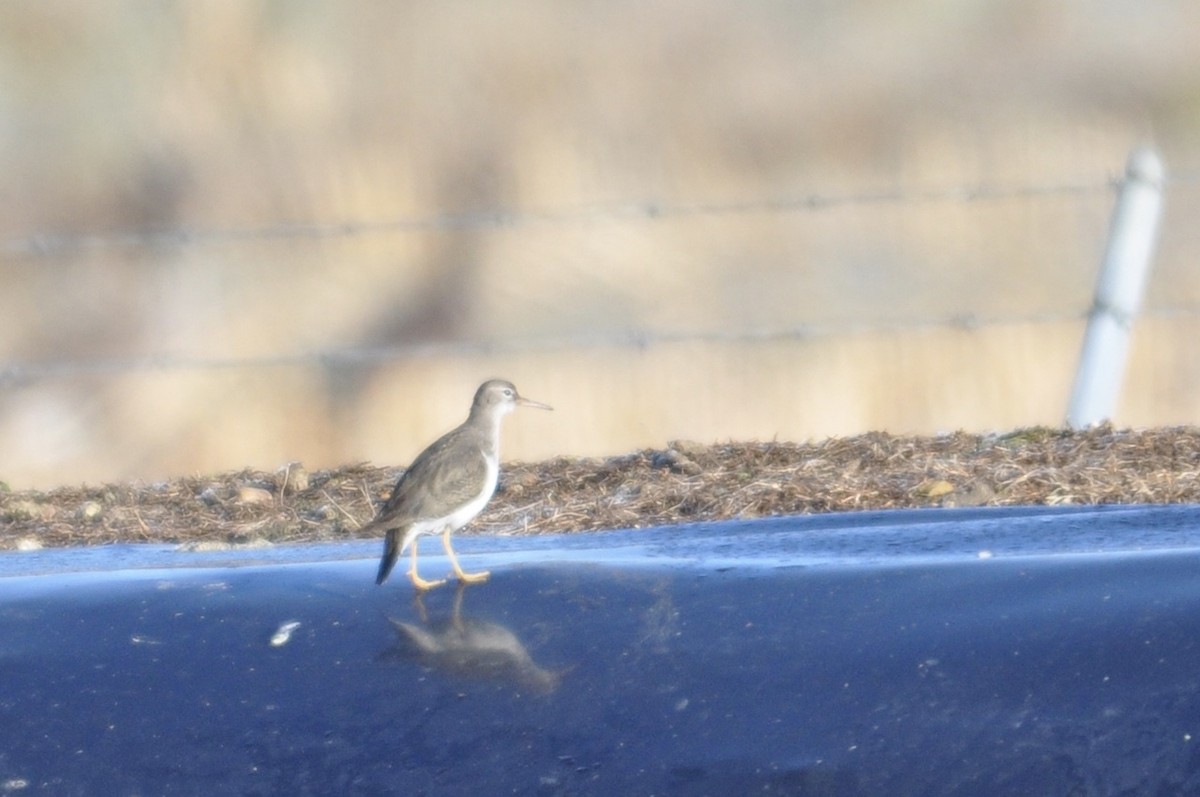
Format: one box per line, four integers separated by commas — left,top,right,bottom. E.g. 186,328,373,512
377,433,487,525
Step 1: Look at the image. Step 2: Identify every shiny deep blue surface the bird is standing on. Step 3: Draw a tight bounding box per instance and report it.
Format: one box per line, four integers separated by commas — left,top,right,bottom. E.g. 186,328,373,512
0,507,1200,795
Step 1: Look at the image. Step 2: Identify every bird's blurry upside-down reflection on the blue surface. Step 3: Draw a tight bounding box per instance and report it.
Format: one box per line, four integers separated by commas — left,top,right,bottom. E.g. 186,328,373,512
380,585,564,693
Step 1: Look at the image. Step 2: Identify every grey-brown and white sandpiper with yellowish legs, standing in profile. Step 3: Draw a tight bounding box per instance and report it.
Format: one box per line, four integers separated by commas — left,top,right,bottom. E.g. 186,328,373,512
360,379,553,592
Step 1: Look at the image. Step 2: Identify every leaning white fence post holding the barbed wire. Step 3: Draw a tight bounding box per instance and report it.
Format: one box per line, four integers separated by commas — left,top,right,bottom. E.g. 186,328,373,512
1067,148,1164,429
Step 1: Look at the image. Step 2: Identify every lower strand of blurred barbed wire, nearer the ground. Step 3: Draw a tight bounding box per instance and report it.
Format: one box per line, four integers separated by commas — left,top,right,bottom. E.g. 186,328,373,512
0,305,1200,389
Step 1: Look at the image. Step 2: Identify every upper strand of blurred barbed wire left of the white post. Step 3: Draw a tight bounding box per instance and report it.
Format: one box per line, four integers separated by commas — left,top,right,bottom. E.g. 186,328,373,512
0,176,1120,258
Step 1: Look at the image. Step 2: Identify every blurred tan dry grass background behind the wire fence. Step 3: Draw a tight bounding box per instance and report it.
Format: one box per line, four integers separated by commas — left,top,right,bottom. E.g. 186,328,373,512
0,0,1200,487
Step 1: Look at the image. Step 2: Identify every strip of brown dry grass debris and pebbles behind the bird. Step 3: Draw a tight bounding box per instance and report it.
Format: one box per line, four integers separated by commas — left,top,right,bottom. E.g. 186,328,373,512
0,426,1200,550
